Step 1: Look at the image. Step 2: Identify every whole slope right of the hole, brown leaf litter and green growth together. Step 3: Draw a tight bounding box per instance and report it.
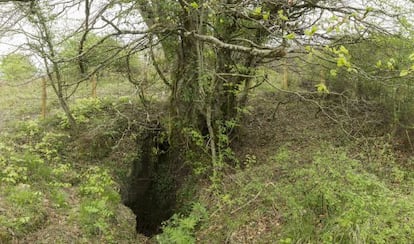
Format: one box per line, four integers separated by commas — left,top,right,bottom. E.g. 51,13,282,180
191,95,414,243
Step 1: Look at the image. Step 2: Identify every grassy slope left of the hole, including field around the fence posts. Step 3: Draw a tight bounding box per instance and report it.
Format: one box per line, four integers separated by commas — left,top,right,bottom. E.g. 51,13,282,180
0,79,147,243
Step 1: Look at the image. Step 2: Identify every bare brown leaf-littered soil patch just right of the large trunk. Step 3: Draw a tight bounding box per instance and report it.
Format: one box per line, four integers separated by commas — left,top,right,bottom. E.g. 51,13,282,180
234,93,347,165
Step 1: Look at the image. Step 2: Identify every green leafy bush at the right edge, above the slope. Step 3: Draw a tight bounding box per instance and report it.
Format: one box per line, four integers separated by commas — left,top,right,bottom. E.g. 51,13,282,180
325,35,414,134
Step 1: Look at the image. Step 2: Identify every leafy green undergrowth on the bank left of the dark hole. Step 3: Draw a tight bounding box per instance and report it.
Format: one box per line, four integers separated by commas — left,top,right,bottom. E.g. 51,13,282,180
0,96,139,243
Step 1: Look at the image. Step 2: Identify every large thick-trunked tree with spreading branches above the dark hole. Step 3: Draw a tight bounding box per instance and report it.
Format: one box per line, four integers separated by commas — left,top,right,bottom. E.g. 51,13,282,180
120,0,402,168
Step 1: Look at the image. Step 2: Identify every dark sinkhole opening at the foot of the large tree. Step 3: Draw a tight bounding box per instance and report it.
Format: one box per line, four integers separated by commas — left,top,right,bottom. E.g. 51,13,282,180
123,123,176,237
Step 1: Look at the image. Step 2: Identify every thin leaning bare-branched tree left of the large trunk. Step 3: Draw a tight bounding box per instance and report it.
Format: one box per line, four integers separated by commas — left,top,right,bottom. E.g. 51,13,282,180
3,0,132,133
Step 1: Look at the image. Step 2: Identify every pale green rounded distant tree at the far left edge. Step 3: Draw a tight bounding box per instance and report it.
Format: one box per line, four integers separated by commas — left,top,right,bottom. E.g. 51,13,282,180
0,53,37,83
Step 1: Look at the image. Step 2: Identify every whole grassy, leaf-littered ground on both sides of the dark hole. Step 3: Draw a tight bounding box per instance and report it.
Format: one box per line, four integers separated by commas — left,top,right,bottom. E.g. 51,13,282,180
0,81,414,243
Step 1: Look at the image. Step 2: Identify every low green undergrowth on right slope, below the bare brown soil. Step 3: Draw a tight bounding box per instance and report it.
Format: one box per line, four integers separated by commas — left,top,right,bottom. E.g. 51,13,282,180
190,145,414,243
